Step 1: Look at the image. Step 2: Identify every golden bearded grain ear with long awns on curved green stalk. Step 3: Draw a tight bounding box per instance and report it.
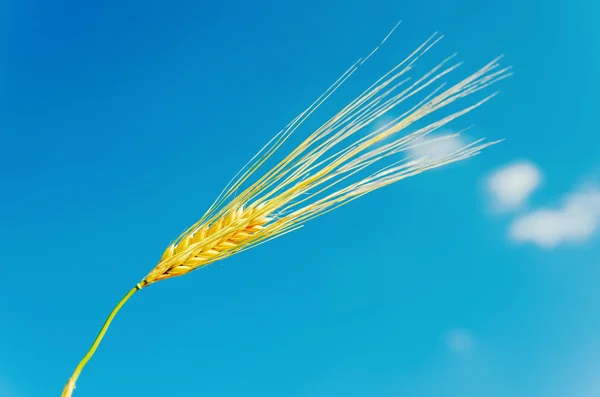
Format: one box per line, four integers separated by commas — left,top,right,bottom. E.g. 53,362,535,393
62,25,510,397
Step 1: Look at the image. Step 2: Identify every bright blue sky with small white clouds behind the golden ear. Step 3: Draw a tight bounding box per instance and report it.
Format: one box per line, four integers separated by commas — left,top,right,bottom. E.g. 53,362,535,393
0,0,600,397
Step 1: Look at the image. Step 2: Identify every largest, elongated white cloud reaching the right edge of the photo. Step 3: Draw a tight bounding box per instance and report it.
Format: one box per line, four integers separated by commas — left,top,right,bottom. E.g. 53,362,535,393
510,187,600,248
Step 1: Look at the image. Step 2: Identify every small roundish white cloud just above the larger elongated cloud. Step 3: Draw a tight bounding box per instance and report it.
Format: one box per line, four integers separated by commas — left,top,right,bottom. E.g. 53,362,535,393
487,161,542,211
